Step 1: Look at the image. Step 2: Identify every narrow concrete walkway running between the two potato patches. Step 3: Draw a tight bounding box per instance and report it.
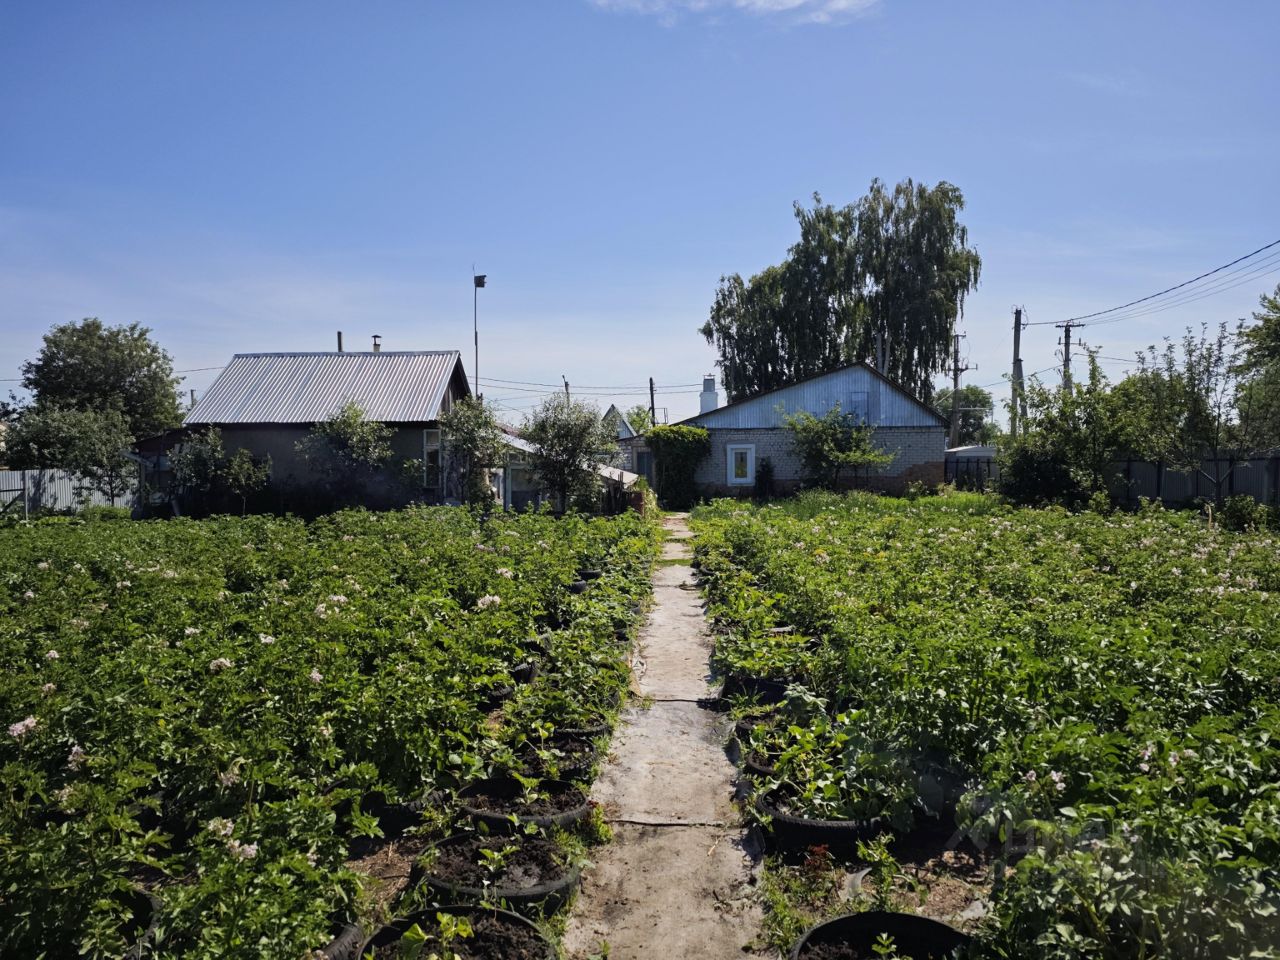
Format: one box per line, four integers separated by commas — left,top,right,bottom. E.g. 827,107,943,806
564,515,760,960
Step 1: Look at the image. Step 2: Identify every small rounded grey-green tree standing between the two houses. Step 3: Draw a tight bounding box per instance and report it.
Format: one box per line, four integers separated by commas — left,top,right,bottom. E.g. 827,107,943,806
521,393,617,509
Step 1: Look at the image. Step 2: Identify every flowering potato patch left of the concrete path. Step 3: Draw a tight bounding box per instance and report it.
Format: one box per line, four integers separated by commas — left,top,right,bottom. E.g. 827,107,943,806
0,508,658,960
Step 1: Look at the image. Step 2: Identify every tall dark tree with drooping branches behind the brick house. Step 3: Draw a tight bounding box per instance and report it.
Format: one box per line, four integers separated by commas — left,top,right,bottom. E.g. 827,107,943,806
700,179,982,401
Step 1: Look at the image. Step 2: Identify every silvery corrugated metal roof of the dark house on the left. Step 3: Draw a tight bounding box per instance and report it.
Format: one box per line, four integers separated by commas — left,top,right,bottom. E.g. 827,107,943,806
183,349,465,425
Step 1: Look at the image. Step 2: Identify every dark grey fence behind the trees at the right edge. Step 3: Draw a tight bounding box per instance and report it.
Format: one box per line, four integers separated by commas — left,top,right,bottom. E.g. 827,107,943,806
945,451,1280,506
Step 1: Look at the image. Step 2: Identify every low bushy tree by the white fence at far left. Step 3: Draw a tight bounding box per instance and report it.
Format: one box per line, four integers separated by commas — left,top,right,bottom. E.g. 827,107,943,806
5,406,134,507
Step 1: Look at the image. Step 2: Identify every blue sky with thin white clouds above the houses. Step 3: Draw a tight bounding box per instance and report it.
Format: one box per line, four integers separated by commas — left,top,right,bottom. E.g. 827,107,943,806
0,0,1280,419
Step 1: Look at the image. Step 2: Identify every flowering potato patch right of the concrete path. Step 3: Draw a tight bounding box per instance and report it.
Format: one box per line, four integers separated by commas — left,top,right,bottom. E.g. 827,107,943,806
694,494,1280,960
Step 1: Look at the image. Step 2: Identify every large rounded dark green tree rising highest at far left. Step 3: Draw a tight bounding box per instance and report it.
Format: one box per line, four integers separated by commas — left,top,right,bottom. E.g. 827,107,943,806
22,317,182,439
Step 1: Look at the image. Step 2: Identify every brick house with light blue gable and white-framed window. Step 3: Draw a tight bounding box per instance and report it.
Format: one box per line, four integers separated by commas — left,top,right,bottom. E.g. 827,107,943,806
620,364,947,497
